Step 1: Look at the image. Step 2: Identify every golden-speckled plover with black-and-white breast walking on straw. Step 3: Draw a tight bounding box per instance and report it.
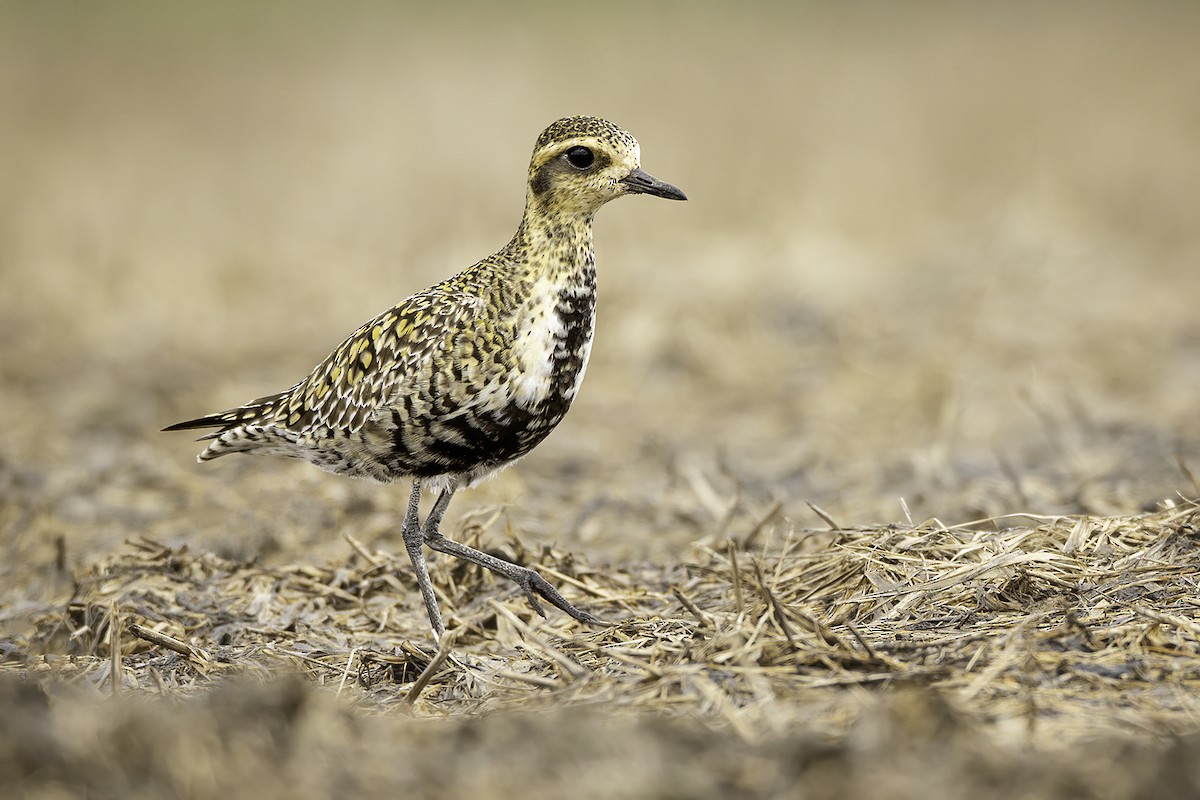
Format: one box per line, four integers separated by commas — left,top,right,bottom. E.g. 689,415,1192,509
163,116,688,639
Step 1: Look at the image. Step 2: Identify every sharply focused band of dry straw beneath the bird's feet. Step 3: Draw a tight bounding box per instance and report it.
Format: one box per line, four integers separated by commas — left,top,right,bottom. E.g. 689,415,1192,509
5,496,1200,744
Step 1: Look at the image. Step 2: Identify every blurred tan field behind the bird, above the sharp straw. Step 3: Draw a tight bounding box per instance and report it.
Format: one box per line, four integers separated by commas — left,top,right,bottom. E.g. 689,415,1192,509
0,0,1200,582
